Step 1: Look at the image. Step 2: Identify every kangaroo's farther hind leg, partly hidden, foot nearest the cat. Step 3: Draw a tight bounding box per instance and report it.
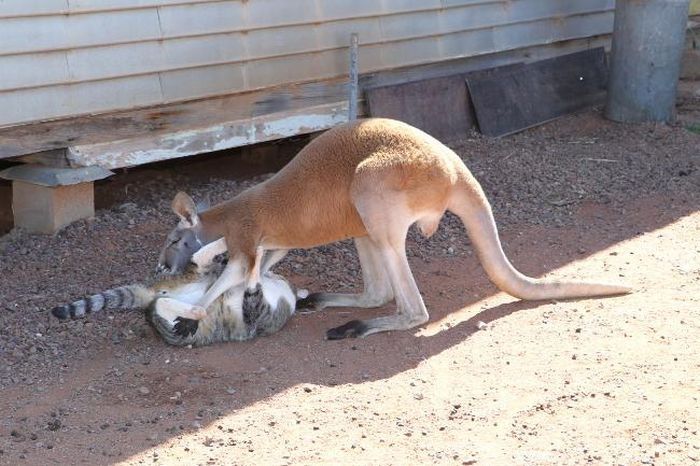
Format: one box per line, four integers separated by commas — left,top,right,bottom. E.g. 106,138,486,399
297,236,394,311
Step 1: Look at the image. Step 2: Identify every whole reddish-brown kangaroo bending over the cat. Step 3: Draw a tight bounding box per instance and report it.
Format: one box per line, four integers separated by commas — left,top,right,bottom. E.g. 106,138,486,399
159,118,631,339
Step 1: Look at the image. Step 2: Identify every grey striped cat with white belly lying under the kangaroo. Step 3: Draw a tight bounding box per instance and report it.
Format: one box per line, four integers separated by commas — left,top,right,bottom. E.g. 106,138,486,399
51,244,306,346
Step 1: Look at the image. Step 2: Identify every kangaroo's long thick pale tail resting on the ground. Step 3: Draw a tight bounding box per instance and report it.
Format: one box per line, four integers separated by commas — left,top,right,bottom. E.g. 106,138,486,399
448,177,632,300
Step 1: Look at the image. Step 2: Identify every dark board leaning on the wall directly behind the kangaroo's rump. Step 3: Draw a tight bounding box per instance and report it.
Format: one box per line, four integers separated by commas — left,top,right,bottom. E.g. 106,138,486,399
366,74,475,142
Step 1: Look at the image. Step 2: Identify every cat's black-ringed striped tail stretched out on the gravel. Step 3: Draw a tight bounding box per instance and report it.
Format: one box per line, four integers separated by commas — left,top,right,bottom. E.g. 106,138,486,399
51,285,155,320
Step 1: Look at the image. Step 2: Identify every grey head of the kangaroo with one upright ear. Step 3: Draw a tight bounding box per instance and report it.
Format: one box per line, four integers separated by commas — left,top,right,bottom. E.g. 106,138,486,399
156,192,205,275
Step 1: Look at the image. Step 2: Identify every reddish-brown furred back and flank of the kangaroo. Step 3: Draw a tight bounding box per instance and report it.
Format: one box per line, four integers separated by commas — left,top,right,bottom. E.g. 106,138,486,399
219,118,466,249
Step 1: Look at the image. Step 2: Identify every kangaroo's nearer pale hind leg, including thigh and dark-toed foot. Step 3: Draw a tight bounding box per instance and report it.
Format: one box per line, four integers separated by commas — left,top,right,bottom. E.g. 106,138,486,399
326,192,428,340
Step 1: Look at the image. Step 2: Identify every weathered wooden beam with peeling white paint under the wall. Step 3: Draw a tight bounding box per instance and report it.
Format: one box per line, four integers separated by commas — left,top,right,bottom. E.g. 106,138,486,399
0,80,347,168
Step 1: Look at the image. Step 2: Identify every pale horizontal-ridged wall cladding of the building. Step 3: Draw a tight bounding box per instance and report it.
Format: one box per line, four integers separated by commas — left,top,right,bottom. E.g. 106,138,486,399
0,0,614,126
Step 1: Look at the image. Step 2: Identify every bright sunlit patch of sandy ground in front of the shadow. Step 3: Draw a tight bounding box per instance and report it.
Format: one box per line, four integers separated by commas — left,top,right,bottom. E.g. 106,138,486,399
124,212,700,465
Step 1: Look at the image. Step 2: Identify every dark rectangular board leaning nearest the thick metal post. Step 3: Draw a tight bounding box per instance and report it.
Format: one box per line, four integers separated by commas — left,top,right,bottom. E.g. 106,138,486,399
466,47,608,136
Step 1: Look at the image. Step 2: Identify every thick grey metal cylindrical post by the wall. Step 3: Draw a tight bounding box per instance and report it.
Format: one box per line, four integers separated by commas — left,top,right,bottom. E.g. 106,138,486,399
605,0,690,122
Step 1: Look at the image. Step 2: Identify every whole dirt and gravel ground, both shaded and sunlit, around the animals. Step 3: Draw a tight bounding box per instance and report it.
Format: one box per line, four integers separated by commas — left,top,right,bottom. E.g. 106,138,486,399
0,83,700,465
